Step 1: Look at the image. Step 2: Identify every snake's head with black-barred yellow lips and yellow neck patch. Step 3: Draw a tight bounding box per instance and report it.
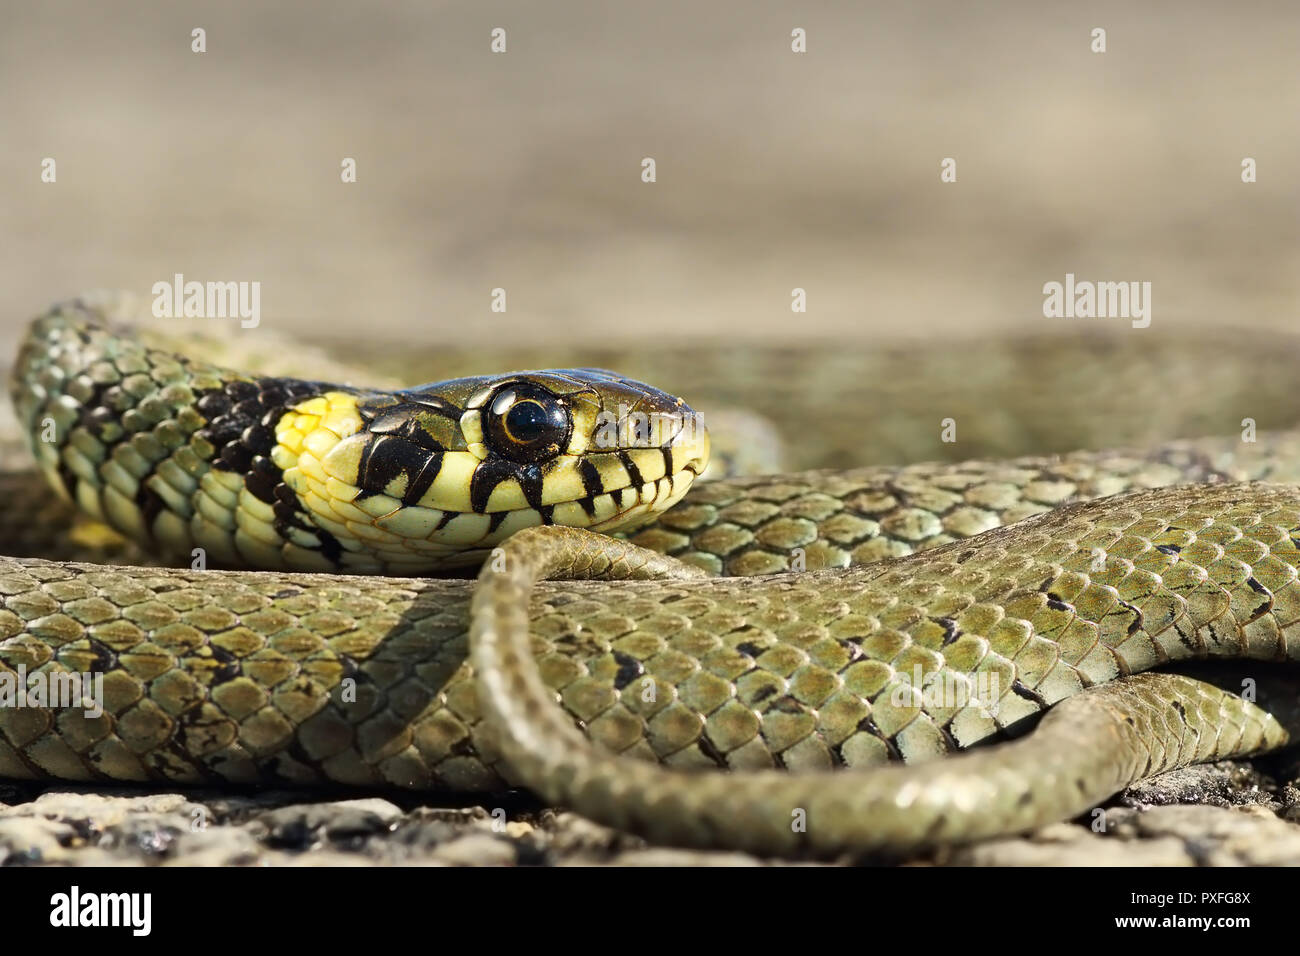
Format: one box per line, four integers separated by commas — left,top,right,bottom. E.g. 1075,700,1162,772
269,368,709,574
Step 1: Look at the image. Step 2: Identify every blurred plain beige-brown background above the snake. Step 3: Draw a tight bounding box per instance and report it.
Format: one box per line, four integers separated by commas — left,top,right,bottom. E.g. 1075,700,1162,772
0,0,1300,355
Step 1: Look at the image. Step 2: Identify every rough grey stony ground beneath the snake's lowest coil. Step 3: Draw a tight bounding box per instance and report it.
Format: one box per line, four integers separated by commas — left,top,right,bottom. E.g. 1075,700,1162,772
0,754,1300,866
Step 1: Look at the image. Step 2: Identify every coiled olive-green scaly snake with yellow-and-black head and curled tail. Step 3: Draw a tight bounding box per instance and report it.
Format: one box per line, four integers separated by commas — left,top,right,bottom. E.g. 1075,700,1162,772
0,304,1300,853
